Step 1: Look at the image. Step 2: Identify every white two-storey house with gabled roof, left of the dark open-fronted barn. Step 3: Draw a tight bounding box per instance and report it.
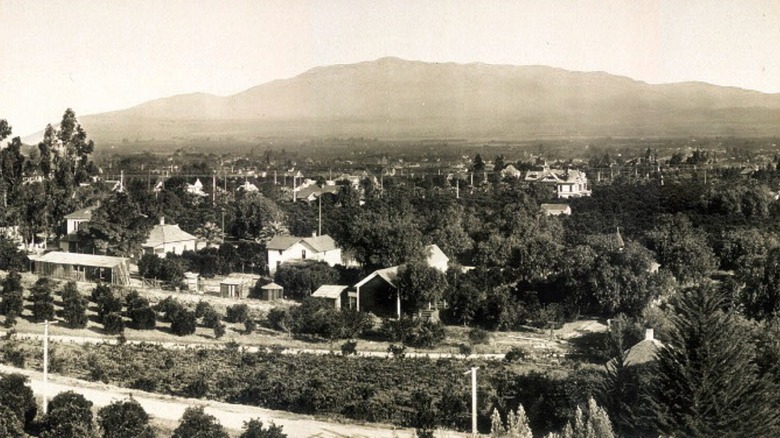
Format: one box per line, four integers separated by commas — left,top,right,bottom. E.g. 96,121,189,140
266,235,342,275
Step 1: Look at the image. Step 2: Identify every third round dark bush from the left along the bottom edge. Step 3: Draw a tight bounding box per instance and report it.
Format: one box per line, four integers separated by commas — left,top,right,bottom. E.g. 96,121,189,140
98,397,155,438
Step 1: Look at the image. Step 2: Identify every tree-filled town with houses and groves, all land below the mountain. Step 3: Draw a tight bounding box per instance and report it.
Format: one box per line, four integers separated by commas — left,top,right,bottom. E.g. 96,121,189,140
0,109,780,438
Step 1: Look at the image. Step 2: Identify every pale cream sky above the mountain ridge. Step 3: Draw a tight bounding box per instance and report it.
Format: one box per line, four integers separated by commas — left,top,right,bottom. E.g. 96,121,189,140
0,0,780,136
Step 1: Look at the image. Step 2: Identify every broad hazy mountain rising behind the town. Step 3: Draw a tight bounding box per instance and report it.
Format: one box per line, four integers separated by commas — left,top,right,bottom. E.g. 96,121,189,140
65,58,780,143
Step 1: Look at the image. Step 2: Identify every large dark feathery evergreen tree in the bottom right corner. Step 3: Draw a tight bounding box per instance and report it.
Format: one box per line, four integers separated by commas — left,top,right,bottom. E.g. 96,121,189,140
654,286,780,437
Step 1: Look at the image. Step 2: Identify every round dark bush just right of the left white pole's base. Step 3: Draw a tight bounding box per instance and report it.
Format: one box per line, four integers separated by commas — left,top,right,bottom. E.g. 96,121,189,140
41,391,93,438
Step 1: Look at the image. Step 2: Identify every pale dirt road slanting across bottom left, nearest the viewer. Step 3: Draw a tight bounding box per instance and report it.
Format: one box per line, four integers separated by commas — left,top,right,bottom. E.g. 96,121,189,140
0,365,468,438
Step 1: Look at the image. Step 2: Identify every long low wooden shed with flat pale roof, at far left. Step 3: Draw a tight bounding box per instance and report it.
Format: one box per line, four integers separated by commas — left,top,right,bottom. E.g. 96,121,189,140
28,251,130,285
